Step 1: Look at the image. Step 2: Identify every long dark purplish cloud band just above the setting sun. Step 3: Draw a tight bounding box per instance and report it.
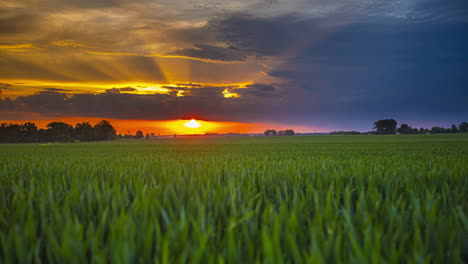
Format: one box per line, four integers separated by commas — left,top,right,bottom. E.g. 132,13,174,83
0,84,286,121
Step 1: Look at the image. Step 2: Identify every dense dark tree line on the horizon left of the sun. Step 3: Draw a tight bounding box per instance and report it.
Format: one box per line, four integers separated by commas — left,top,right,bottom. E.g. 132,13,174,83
0,120,116,143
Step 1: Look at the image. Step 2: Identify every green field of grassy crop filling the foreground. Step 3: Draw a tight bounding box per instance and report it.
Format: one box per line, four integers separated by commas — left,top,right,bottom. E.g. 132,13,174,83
0,135,468,263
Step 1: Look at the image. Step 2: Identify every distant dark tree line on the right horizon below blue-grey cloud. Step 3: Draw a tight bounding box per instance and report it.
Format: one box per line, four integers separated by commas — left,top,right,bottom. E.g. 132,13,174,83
330,119,468,135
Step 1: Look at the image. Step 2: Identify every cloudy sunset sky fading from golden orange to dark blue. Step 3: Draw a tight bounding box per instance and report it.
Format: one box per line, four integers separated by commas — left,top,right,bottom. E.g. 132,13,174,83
0,0,468,133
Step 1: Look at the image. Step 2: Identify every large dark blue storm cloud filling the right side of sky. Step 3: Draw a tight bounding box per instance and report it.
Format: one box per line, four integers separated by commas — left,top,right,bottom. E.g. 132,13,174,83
205,4,468,127
